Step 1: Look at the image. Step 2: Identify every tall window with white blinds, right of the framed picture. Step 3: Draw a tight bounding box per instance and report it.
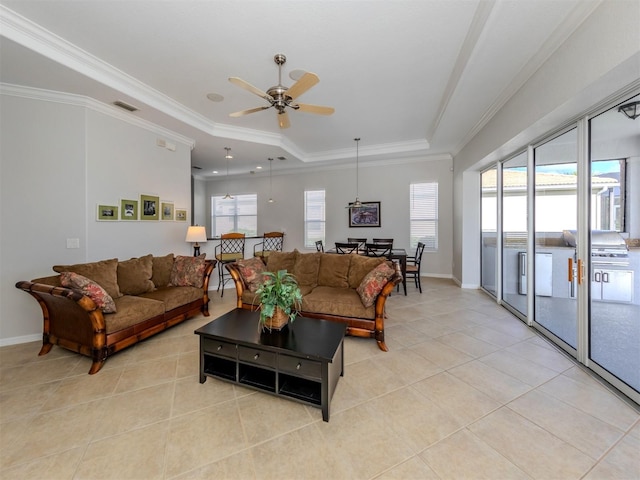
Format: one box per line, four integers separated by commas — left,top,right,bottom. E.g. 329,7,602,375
409,182,438,251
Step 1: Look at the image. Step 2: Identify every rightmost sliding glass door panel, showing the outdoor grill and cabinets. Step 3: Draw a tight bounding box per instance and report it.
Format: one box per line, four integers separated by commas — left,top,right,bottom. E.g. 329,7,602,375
589,96,640,392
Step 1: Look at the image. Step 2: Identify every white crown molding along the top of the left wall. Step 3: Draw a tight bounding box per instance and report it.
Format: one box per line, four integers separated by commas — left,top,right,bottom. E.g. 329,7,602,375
0,83,195,150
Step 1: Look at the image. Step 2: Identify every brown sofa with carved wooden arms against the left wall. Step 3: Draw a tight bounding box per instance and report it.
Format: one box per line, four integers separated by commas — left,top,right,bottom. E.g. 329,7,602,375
16,254,216,374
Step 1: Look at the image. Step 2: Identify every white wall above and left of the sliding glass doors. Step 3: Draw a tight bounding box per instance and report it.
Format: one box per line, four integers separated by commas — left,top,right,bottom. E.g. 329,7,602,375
453,0,640,287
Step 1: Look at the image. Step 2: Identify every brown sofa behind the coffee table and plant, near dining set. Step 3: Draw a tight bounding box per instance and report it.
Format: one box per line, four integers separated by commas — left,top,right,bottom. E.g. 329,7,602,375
225,250,402,352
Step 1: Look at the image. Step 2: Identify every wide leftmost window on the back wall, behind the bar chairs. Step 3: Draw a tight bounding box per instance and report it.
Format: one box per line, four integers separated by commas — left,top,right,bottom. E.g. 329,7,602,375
211,193,258,237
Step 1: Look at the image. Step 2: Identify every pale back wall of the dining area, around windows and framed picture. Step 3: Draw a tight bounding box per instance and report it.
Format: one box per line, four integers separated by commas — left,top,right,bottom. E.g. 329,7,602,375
195,159,452,277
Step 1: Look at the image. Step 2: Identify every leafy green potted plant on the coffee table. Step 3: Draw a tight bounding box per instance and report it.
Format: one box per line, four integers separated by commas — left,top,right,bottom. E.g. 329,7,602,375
256,270,302,330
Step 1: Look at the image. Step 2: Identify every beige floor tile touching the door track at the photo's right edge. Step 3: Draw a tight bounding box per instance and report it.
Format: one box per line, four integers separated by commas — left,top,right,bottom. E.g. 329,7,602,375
539,375,640,431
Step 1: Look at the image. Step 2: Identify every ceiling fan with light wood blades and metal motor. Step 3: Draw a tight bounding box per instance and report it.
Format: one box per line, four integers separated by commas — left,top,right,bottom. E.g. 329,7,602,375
229,53,335,128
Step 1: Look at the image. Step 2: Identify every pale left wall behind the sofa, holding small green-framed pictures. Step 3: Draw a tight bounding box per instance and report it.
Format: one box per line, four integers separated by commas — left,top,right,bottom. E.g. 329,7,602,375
0,92,191,345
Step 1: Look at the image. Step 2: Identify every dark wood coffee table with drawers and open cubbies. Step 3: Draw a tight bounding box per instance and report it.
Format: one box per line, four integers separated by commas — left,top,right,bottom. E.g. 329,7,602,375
195,308,346,422
